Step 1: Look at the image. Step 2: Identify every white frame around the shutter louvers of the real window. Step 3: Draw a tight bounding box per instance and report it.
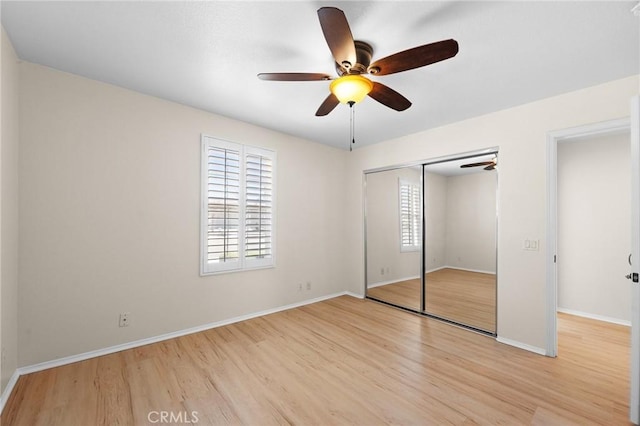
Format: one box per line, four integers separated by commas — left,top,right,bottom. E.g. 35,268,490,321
200,134,276,276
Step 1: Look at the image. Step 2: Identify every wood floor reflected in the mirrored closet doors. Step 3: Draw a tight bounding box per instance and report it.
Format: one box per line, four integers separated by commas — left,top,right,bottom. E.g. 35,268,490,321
367,268,496,333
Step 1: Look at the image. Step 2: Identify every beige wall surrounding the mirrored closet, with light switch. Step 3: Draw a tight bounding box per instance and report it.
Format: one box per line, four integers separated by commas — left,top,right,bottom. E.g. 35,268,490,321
345,76,638,349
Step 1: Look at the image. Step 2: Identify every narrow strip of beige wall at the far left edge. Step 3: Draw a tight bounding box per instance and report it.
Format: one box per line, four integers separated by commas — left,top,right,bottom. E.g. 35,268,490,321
0,28,19,394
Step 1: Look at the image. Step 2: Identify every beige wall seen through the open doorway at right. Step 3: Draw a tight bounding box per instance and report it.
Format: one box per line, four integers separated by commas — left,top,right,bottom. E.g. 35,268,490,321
557,132,632,322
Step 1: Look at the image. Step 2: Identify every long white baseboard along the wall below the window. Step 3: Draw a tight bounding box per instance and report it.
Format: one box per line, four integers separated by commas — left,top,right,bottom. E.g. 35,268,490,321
17,291,352,376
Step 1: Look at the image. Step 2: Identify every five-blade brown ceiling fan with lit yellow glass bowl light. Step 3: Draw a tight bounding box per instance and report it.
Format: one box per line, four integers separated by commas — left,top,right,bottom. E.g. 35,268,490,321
258,7,458,116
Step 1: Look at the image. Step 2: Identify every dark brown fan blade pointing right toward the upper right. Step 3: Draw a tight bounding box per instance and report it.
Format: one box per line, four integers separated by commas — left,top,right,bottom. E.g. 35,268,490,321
369,39,458,75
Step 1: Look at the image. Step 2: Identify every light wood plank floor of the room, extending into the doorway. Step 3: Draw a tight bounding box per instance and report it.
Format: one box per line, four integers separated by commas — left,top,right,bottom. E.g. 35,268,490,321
1,296,629,426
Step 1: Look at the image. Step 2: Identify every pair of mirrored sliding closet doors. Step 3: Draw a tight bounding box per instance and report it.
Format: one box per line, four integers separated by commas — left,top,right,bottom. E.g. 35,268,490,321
365,152,497,334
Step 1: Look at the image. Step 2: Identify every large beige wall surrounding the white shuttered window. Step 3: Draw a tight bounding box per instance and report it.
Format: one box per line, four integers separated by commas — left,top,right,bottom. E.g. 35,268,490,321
19,62,347,366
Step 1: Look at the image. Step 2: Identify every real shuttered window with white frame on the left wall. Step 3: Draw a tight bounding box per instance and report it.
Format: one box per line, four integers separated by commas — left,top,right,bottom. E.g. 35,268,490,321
201,136,275,275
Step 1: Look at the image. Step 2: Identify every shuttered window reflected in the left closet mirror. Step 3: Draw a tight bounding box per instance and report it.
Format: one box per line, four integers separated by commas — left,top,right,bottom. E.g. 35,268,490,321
398,179,422,251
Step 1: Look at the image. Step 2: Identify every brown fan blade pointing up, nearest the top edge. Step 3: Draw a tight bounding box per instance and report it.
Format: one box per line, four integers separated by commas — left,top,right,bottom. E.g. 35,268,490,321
318,7,357,69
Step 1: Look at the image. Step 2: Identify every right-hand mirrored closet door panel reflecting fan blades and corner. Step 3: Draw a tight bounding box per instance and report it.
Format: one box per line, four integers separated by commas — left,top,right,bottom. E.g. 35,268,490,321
424,155,497,333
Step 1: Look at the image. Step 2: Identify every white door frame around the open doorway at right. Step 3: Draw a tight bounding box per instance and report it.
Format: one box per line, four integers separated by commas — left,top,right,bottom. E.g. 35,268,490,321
545,117,631,357
